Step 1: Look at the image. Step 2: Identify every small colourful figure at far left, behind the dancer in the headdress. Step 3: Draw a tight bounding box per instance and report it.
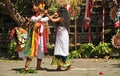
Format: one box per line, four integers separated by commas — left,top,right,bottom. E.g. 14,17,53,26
10,26,27,59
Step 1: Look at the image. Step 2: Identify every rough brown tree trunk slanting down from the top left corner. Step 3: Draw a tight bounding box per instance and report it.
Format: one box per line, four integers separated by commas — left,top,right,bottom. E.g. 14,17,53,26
4,0,27,25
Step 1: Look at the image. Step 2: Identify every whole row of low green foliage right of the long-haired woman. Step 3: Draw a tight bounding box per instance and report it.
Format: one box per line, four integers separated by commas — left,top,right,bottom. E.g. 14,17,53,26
69,42,112,58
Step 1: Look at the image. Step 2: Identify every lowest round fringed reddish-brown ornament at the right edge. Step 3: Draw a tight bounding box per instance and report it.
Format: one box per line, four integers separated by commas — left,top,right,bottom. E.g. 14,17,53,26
111,30,120,48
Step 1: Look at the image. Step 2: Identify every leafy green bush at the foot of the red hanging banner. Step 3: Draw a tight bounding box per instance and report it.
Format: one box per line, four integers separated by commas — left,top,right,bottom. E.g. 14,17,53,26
79,43,96,57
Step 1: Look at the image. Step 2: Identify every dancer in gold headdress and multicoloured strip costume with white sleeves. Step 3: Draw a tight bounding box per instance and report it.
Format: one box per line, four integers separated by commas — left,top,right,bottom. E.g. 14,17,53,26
24,3,49,70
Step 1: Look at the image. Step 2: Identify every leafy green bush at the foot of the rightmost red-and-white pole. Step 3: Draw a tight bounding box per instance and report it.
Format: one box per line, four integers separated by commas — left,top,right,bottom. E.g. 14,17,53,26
96,42,112,57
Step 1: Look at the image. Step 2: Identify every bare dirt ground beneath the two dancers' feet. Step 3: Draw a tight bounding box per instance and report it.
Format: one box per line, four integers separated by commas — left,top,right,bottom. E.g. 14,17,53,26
0,57,120,76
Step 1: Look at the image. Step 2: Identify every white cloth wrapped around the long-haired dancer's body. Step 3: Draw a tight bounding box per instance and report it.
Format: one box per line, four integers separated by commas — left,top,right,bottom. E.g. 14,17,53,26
54,26,69,56
